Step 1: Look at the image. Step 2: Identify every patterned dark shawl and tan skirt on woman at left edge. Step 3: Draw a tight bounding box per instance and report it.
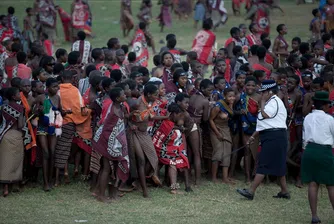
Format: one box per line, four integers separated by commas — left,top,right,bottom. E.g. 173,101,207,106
0,103,24,184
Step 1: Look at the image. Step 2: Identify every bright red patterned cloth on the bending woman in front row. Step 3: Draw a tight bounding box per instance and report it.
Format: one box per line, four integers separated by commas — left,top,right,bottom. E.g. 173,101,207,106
153,120,189,169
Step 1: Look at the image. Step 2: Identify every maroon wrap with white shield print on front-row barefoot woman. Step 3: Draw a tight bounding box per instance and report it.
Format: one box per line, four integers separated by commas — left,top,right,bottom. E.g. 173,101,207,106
92,108,130,182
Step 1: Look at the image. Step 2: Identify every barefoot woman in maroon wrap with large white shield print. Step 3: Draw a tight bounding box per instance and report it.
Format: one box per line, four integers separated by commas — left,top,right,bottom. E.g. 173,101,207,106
92,87,129,202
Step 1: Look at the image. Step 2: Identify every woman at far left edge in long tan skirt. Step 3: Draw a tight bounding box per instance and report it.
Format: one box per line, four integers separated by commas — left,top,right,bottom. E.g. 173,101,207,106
0,87,25,197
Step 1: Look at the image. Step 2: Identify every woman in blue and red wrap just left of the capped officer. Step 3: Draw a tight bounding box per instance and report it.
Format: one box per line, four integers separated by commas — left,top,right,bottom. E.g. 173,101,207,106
240,76,261,183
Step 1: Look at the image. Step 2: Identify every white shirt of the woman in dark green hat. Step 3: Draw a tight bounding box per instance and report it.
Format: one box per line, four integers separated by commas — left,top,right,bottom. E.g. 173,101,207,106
303,110,334,145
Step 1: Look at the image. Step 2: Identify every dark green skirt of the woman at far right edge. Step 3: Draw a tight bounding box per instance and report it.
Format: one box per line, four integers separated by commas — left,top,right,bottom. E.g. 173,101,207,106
301,143,334,186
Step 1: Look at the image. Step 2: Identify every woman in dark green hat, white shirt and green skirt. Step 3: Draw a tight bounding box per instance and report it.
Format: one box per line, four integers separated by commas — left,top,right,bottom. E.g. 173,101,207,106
301,92,334,223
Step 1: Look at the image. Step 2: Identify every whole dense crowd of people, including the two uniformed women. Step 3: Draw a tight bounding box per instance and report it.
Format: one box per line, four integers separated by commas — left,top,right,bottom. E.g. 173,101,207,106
0,0,334,223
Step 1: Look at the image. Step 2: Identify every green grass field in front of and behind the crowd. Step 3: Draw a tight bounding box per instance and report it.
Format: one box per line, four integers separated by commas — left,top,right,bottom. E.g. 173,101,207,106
0,0,334,224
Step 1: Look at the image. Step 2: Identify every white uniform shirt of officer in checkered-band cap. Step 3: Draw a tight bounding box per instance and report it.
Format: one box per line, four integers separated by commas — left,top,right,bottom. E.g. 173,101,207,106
256,95,287,131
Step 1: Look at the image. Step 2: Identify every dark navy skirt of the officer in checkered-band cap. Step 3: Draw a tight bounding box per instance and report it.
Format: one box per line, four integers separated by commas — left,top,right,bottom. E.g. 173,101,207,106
256,129,288,177
